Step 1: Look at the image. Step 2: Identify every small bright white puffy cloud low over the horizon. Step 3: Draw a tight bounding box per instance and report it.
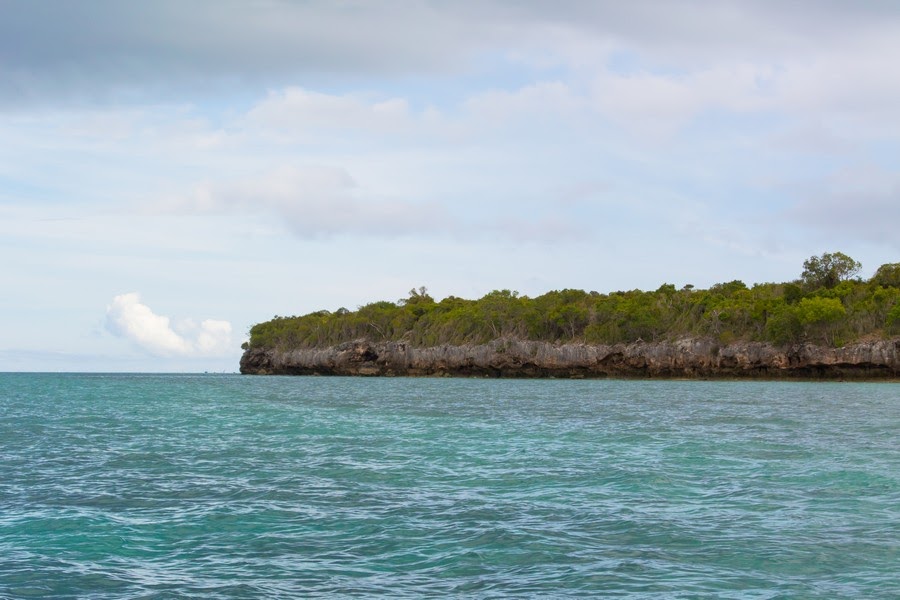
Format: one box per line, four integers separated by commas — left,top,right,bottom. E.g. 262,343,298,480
105,292,233,357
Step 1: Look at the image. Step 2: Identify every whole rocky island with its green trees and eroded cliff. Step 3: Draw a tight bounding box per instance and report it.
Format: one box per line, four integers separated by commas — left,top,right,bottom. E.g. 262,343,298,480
240,252,900,380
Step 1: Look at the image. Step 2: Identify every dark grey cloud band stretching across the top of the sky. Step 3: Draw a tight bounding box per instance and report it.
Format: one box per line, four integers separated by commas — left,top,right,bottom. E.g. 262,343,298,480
0,0,888,106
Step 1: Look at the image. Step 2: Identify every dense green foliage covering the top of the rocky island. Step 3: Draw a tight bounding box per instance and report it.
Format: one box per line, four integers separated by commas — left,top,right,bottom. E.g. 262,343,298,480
244,252,900,348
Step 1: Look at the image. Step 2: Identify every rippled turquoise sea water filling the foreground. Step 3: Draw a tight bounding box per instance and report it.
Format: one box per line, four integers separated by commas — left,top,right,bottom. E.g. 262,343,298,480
0,374,900,598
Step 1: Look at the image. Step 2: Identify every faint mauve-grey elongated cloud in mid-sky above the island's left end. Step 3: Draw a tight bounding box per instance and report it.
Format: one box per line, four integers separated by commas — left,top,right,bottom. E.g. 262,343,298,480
152,166,588,243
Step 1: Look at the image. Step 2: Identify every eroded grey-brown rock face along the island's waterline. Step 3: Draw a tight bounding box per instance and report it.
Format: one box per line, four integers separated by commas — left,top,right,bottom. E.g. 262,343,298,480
241,339,900,379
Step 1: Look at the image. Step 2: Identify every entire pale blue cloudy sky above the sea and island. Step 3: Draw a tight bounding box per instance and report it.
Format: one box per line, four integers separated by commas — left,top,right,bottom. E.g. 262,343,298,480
0,0,900,372
